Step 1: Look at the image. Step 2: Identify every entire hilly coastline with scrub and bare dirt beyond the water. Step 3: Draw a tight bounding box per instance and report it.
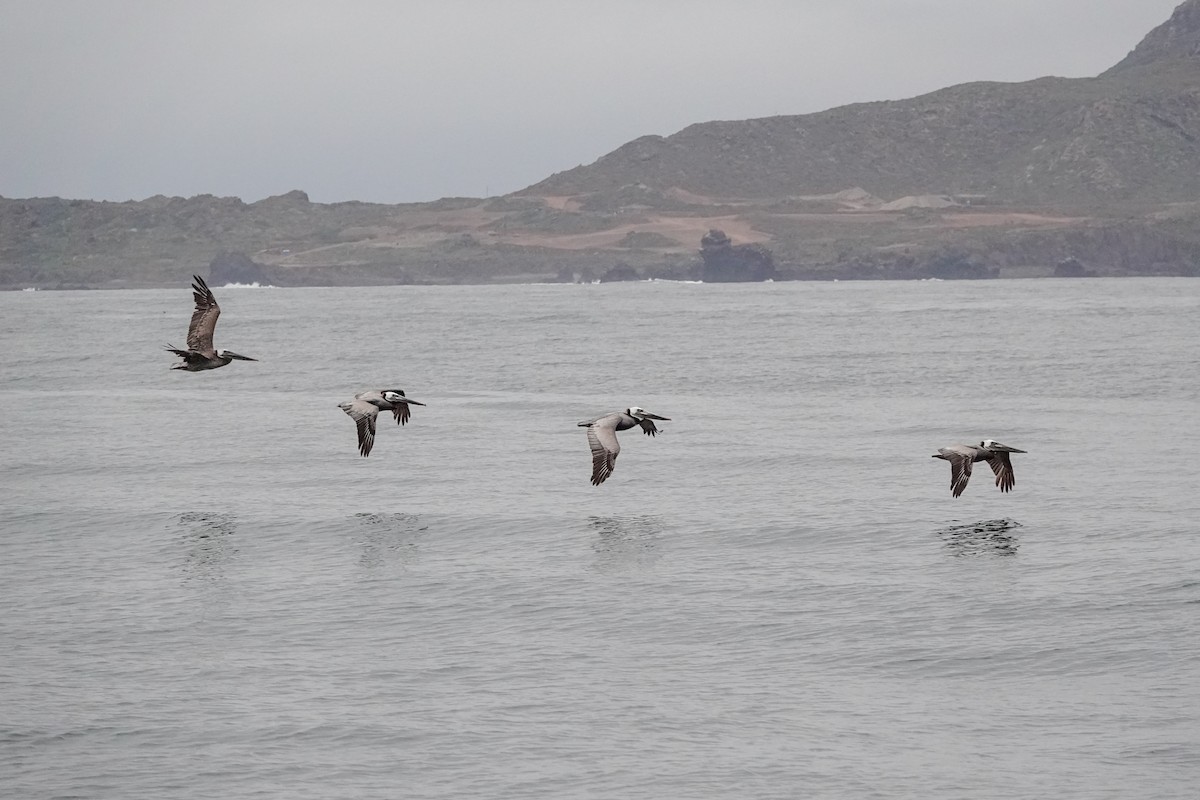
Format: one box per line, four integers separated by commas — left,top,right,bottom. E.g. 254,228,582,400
0,0,1200,289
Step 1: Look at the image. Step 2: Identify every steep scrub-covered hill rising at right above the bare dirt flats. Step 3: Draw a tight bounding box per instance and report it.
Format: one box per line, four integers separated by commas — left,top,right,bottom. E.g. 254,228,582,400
523,0,1200,207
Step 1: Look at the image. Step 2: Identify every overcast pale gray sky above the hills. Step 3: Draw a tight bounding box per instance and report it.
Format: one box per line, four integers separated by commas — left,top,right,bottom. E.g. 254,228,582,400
0,0,1180,203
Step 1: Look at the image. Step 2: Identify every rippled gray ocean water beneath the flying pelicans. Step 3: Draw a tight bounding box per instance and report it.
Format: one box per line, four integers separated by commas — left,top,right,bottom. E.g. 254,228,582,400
0,278,1200,800
